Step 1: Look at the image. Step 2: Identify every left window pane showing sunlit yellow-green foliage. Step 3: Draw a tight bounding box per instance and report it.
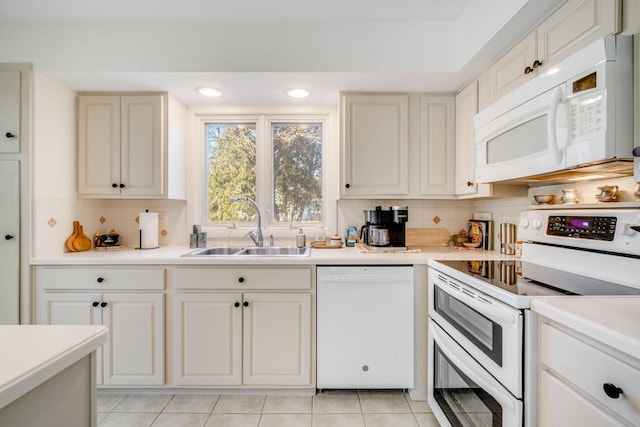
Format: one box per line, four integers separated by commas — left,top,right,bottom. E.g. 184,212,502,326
205,123,256,222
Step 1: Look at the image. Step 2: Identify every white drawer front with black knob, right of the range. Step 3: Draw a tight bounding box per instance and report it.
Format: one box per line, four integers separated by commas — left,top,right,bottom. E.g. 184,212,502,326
540,323,640,425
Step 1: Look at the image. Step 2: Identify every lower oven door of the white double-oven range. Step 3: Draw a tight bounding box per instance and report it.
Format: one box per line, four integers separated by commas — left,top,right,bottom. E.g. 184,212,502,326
427,319,523,427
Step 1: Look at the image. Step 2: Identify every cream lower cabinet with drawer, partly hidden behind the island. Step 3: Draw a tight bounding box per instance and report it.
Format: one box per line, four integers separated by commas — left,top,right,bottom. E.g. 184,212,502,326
36,267,165,386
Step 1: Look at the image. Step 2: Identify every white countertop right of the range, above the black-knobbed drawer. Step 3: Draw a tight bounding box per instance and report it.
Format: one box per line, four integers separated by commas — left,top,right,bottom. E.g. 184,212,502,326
531,296,640,359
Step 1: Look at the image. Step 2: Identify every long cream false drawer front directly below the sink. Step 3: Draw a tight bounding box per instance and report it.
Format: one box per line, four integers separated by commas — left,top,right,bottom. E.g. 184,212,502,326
175,267,311,289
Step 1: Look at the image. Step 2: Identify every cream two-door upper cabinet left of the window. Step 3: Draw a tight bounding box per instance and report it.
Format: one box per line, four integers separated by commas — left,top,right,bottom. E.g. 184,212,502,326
78,94,185,199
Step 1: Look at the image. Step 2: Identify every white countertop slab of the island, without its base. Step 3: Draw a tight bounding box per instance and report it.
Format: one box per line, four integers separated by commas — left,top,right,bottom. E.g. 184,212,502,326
0,325,107,408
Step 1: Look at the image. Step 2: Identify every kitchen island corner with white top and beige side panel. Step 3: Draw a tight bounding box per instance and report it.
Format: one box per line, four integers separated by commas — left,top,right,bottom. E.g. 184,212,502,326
0,325,107,426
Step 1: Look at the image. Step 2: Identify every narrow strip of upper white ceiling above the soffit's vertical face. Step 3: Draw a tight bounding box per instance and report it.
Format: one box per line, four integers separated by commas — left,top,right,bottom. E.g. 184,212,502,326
0,0,473,22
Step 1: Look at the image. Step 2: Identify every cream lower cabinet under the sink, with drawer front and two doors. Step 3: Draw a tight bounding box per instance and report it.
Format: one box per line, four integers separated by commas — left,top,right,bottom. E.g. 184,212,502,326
174,267,313,386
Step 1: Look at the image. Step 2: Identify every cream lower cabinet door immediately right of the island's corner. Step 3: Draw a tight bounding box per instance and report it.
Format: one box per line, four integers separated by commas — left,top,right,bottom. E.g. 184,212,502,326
102,293,164,385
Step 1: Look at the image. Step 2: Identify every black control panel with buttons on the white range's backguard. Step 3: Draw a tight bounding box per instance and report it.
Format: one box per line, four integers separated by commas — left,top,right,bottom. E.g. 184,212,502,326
547,215,618,242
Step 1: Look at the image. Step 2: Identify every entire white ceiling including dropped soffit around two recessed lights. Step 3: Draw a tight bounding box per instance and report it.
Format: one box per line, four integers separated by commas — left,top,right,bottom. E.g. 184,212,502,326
0,0,562,106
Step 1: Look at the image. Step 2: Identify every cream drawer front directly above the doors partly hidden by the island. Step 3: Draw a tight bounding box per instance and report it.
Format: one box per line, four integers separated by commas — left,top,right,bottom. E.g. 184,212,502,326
36,267,164,290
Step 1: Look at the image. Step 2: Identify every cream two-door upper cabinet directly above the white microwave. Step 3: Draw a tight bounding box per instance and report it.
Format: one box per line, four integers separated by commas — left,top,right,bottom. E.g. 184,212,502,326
481,0,622,107
